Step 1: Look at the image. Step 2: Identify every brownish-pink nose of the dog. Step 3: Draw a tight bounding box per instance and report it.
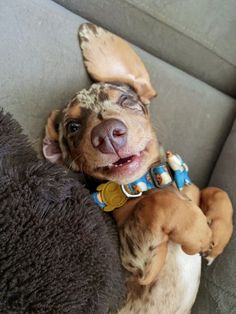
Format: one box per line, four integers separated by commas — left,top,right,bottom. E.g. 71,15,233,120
91,119,127,154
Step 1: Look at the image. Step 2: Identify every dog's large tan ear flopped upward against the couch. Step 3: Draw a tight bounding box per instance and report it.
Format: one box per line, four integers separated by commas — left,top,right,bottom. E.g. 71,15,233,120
79,23,157,104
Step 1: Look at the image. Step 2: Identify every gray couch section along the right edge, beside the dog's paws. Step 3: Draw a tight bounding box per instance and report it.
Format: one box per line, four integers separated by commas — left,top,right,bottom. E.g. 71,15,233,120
193,121,236,314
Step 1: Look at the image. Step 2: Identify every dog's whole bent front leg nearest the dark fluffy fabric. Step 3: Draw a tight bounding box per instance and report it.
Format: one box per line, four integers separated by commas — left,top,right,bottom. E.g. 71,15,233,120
115,188,211,285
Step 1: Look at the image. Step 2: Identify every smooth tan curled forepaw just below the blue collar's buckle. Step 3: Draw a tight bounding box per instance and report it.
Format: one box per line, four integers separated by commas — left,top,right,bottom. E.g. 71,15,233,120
145,189,212,255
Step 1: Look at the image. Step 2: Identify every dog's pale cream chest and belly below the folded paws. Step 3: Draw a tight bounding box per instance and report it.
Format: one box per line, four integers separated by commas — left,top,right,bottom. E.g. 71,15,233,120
119,242,201,314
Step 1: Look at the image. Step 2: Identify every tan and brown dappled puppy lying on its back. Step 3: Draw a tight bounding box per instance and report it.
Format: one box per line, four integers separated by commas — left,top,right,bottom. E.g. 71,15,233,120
43,24,233,314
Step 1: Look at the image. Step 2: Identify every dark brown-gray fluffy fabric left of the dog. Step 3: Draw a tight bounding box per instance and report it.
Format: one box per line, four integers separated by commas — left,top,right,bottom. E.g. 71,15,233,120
0,111,125,314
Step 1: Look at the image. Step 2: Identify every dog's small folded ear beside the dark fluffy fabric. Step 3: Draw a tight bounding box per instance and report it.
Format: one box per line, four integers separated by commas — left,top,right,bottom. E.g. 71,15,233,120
43,110,62,163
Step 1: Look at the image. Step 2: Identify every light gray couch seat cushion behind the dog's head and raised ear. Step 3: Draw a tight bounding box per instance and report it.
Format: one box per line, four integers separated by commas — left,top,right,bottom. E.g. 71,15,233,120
0,0,236,189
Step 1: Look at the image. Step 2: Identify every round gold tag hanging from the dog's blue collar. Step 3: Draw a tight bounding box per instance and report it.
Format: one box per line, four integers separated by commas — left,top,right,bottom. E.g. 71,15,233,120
97,182,128,212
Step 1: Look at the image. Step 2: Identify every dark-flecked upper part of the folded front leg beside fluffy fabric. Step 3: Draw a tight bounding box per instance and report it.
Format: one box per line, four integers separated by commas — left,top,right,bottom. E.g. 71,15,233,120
113,196,168,285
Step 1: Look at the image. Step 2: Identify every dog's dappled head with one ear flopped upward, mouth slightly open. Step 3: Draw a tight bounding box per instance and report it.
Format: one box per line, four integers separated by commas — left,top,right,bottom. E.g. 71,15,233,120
43,24,159,184
